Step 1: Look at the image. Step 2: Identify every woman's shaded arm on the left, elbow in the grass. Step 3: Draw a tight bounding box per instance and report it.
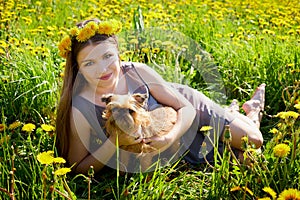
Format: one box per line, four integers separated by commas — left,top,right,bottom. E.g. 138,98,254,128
67,108,141,174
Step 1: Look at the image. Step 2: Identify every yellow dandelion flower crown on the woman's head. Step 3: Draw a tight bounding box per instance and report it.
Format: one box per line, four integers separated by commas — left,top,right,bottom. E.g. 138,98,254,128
58,20,122,58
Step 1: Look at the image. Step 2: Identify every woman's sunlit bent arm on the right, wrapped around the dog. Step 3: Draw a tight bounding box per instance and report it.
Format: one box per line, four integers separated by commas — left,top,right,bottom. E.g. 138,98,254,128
135,63,196,151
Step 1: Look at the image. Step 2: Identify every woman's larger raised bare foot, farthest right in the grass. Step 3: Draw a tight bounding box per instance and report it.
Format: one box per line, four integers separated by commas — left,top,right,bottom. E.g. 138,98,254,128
242,83,266,128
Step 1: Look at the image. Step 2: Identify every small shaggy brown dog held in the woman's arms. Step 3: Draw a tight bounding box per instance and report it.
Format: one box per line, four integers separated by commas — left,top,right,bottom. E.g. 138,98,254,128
101,93,177,169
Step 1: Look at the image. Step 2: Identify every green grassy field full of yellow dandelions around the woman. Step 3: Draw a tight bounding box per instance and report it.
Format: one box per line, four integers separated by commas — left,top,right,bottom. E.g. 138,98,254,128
0,0,300,200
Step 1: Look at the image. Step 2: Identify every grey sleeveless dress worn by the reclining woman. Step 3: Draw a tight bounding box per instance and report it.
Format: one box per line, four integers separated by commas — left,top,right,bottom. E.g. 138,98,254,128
72,63,234,170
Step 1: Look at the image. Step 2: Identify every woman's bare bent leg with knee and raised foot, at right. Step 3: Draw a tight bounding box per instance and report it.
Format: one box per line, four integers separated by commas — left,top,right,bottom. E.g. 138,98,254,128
224,84,265,149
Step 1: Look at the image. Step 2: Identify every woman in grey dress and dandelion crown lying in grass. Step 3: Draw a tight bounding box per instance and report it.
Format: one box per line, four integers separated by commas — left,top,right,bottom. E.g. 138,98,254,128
56,19,265,173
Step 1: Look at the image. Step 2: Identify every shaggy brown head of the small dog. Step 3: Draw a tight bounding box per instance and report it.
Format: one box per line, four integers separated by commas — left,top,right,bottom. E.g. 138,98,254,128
101,93,150,134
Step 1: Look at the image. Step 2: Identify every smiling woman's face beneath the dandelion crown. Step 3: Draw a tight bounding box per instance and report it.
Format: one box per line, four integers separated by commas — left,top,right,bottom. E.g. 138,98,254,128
77,41,120,92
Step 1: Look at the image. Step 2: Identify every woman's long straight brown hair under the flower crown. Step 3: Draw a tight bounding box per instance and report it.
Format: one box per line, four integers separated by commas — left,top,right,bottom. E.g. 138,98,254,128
55,19,118,158
